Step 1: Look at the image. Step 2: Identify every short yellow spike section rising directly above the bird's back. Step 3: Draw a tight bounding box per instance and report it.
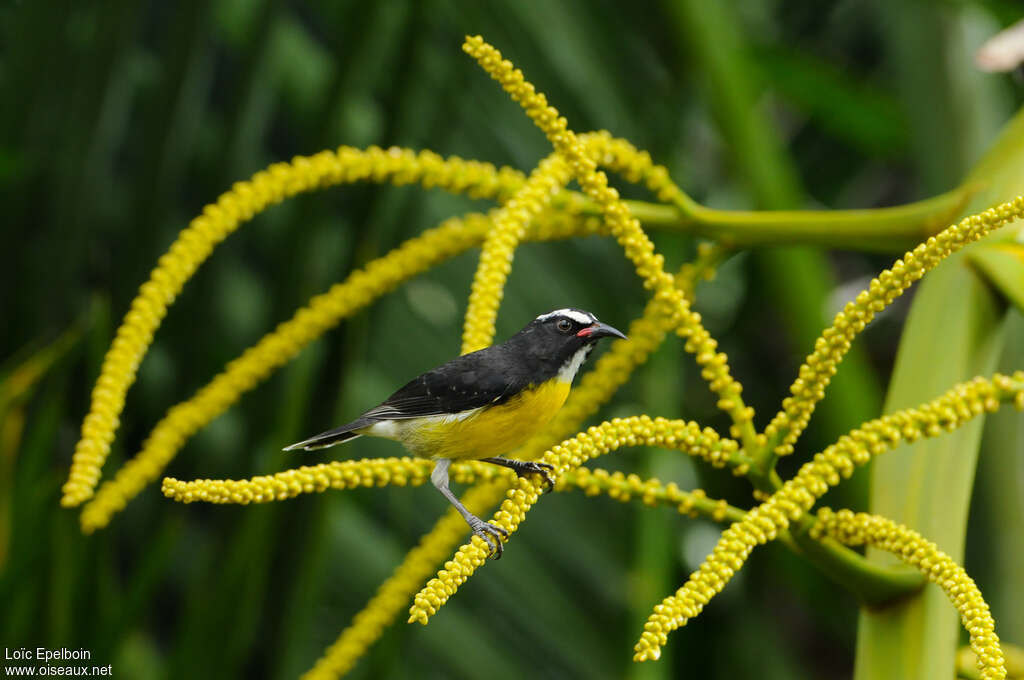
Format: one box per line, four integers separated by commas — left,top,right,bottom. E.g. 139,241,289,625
462,155,569,354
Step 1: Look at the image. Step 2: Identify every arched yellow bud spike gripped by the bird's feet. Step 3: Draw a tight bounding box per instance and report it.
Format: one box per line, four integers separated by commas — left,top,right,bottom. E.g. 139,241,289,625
410,416,738,624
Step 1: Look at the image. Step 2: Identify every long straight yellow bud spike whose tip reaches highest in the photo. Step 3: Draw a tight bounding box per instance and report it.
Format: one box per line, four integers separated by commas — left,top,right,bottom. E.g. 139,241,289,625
463,36,755,443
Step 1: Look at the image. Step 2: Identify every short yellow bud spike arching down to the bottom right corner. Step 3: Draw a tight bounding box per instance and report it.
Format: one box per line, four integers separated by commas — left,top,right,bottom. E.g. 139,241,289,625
812,508,1007,680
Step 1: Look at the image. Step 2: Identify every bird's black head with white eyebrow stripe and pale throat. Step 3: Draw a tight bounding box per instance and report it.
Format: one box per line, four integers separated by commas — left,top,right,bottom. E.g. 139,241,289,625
509,308,626,381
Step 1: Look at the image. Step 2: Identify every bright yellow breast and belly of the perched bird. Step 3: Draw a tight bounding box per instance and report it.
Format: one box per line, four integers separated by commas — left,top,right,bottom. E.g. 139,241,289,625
395,378,571,459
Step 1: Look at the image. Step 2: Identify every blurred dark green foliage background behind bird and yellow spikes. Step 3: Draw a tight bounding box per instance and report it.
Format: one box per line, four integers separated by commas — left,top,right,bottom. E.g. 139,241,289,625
0,0,1024,678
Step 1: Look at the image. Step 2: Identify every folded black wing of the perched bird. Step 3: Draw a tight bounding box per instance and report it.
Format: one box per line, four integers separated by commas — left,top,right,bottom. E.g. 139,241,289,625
361,346,526,420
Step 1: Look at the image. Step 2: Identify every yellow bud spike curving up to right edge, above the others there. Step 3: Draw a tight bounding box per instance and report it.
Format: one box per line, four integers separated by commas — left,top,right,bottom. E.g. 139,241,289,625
765,197,1024,456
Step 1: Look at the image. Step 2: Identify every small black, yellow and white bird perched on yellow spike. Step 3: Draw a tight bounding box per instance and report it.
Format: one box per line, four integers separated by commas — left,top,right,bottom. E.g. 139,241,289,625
285,309,626,559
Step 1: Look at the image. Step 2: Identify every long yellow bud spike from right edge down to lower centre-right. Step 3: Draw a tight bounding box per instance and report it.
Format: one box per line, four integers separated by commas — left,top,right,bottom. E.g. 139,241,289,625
633,372,1024,662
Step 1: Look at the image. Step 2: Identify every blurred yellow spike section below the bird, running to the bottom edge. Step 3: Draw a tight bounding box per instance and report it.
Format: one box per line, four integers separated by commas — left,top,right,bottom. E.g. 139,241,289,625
302,483,507,680
